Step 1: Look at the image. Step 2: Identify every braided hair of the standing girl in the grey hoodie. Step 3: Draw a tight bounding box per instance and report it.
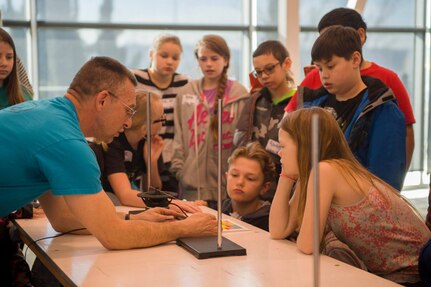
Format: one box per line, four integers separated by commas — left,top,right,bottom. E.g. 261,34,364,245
194,35,230,141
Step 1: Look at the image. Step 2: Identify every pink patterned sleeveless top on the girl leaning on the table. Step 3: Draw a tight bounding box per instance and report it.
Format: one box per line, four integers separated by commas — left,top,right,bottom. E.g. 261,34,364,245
328,187,431,283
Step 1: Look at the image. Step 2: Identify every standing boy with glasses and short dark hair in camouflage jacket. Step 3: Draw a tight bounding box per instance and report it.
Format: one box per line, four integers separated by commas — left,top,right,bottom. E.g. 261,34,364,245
234,41,296,200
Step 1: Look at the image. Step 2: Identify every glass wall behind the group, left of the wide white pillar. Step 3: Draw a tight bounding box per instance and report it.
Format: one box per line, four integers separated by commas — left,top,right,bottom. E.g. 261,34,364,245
0,0,278,98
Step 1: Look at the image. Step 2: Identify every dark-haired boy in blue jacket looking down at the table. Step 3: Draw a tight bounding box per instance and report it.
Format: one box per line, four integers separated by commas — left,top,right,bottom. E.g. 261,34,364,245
297,26,406,190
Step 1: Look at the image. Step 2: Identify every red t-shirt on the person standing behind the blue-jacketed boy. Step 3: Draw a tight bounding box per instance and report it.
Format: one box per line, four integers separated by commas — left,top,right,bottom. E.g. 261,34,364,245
285,63,416,125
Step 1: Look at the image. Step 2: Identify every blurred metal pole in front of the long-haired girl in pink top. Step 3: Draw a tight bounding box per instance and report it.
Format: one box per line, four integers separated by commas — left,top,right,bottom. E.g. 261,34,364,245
311,114,320,287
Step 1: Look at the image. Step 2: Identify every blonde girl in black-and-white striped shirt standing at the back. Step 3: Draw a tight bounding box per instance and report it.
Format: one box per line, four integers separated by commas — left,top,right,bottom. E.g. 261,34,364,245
132,34,188,196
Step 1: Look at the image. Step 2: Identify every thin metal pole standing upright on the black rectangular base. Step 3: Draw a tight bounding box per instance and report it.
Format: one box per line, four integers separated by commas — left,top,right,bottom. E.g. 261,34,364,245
217,99,223,249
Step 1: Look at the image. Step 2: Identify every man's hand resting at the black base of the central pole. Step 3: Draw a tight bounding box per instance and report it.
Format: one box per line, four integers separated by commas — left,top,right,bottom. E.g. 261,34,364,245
182,212,217,237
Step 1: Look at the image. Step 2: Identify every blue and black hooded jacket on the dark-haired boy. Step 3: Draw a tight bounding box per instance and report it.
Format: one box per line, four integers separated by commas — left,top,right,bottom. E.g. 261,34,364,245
298,76,406,190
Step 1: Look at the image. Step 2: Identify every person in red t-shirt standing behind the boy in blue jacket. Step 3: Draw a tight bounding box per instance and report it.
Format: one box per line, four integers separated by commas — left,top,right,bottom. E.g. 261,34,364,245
285,8,416,169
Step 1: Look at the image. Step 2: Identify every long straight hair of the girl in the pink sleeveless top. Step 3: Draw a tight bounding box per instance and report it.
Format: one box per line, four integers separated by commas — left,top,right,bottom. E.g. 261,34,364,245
280,107,408,226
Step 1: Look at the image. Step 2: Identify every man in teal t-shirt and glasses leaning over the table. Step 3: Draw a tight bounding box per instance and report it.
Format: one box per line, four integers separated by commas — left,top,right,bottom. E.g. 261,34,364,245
0,57,217,249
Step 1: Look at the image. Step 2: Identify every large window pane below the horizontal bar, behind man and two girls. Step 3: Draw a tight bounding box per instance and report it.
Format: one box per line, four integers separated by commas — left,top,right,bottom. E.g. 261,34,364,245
39,29,245,98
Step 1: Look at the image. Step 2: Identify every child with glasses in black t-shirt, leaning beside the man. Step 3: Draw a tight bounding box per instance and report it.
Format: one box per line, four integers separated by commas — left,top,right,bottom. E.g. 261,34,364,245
90,91,200,213
